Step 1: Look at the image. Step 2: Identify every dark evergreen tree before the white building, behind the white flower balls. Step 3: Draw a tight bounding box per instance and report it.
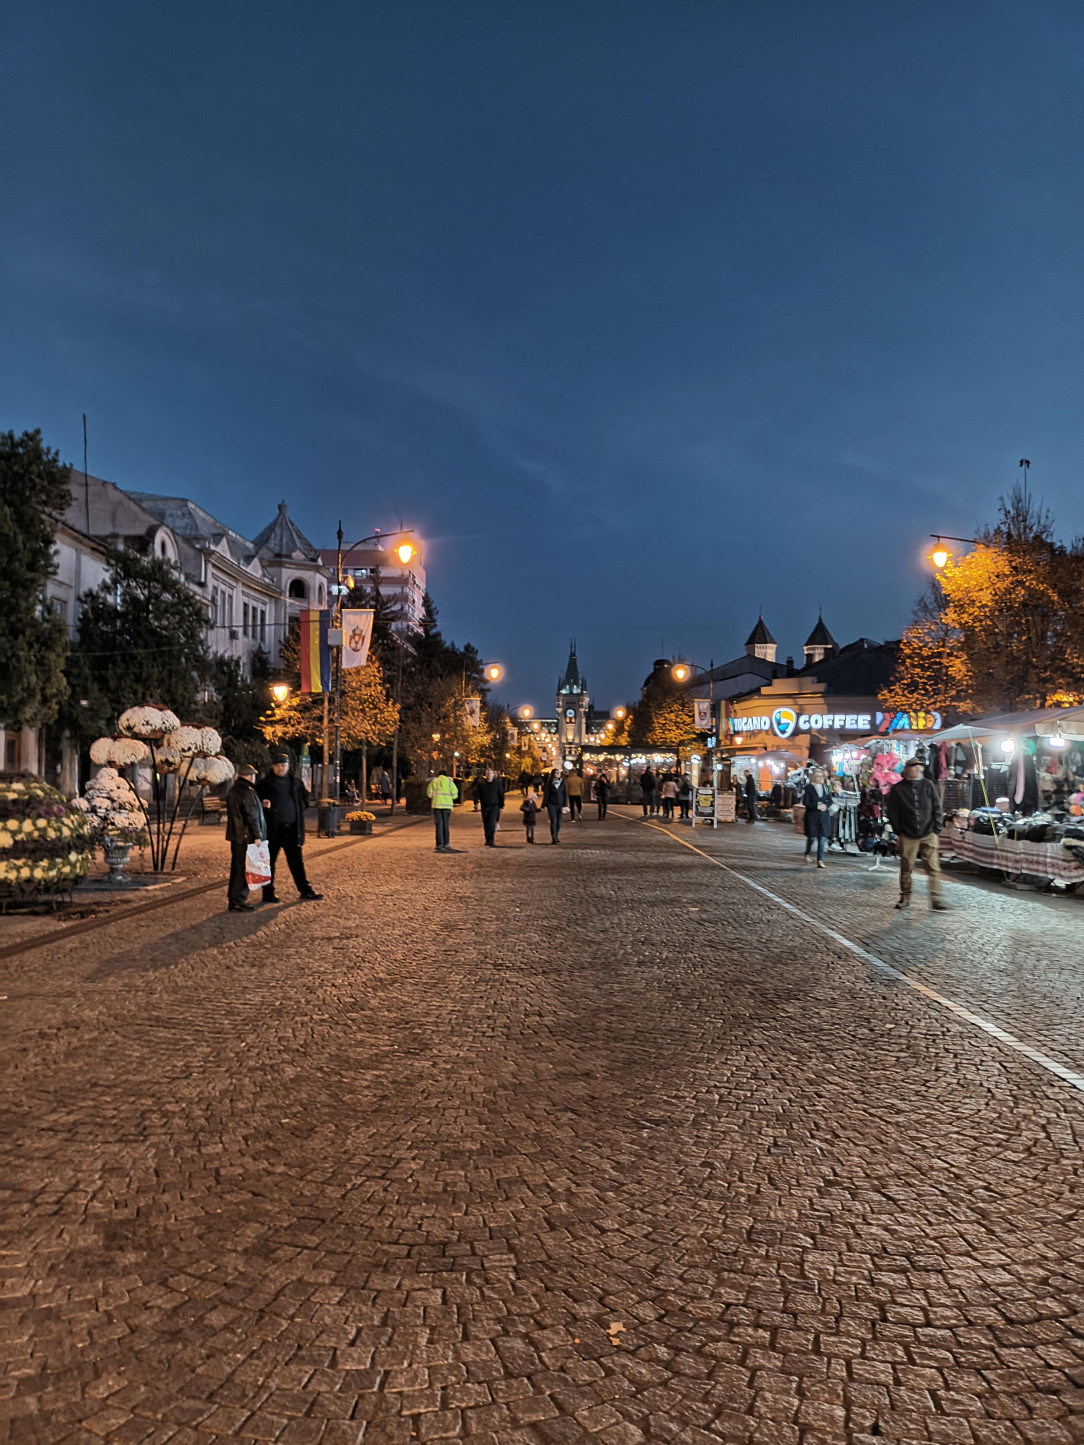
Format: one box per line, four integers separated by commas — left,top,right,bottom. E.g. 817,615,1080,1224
68,552,210,733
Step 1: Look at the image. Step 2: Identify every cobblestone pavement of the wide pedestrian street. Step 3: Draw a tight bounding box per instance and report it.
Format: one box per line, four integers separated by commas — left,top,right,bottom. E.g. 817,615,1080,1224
0,811,1084,1445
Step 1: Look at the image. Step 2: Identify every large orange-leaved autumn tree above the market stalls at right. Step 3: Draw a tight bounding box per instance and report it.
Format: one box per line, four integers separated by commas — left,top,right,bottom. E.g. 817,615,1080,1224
882,487,1084,714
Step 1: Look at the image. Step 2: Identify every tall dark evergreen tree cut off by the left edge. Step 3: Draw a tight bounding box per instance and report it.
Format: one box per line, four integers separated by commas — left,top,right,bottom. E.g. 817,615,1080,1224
0,431,71,727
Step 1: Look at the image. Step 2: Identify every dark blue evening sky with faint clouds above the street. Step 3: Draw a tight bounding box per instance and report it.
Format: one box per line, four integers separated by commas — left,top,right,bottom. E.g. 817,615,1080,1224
0,0,1084,707
